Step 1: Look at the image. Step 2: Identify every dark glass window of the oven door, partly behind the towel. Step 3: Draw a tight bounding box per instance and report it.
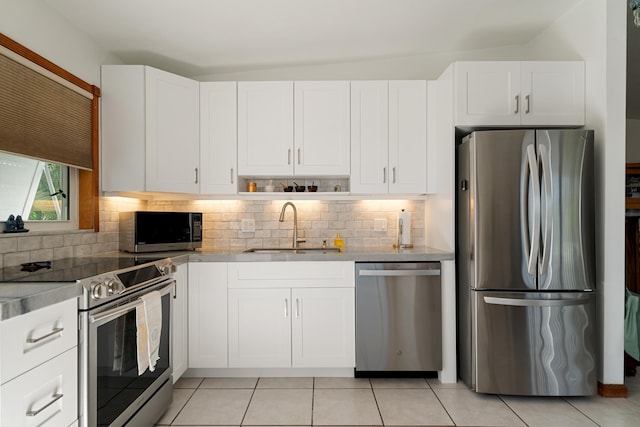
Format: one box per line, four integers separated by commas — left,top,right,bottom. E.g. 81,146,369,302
96,293,171,426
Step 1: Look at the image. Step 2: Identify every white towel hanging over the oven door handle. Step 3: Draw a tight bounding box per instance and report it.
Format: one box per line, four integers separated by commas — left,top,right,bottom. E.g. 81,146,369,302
136,291,162,375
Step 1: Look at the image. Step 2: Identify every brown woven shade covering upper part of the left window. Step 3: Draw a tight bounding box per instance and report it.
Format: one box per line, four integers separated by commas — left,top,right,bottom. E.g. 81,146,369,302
0,54,93,170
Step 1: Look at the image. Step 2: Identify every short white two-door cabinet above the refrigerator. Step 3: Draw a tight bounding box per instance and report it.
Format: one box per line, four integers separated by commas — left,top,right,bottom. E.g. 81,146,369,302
454,61,585,126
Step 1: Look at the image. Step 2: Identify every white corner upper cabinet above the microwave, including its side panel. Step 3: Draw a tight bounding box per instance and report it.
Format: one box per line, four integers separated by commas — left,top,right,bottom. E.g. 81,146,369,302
101,65,200,193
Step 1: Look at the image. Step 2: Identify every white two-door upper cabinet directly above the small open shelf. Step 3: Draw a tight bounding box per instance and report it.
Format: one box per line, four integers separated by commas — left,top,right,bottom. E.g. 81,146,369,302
238,81,350,176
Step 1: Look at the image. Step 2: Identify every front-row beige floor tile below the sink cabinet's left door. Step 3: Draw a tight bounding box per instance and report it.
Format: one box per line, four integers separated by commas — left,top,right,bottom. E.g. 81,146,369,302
242,389,313,426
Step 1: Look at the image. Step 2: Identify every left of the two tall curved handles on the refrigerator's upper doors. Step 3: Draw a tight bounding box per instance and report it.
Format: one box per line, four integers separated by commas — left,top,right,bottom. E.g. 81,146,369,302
520,144,540,275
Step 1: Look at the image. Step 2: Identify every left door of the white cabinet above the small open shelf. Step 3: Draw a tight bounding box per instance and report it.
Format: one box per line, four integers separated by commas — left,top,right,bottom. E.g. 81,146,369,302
238,81,294,176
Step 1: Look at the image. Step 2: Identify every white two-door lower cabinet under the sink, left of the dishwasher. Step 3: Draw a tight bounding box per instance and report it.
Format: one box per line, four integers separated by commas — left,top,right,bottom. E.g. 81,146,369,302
229,262,355,368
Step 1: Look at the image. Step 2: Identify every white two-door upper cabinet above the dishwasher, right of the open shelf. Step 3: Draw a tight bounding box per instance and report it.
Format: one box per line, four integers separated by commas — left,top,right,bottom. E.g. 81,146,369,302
351,80,427,194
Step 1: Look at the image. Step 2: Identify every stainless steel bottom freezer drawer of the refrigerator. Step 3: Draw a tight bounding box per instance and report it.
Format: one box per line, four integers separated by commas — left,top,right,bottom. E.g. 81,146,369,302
472,291,597,396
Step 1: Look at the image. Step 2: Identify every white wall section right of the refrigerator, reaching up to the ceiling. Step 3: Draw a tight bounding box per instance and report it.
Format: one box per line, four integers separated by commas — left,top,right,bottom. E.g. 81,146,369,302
527,0,627,384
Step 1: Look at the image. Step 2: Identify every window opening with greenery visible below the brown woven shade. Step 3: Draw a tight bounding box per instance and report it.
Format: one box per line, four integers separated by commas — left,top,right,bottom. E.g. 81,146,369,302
0,152,77,229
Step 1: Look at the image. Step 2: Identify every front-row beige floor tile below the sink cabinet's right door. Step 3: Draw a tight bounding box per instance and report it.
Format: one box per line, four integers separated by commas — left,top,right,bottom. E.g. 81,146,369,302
313,389,382,426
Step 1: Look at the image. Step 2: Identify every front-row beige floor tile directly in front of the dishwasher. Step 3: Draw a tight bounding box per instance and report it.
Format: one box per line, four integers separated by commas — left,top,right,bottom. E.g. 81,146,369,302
373,388,453,426
